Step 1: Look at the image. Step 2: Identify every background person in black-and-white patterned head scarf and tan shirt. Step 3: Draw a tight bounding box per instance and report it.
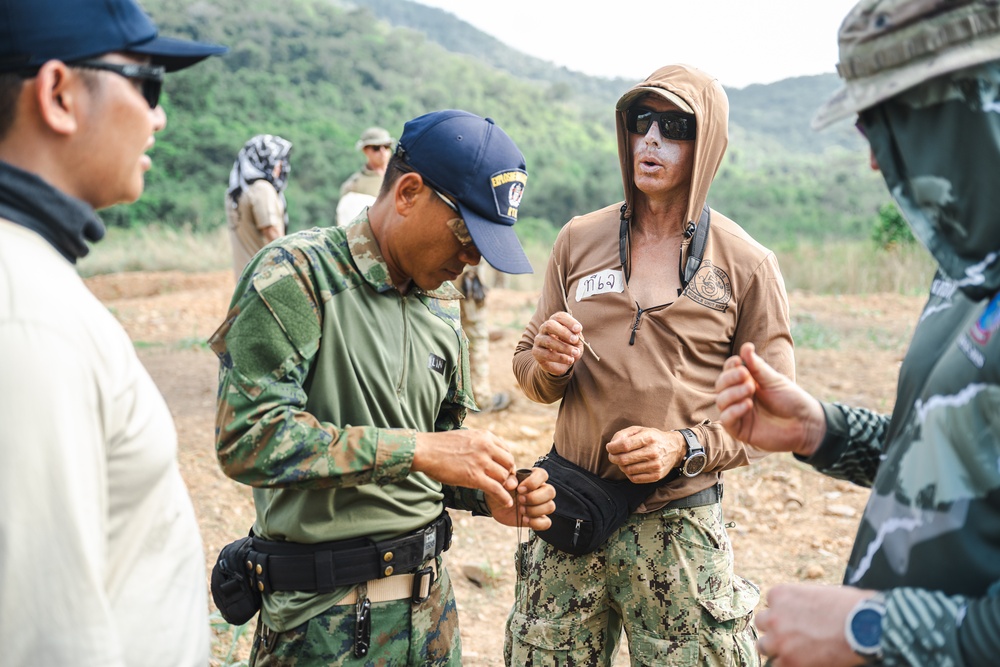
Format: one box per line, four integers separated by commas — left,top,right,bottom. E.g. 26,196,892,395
226,134,292,279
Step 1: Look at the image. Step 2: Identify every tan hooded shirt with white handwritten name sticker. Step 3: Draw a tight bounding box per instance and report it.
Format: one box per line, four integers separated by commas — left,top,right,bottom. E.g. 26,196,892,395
513,65,794,511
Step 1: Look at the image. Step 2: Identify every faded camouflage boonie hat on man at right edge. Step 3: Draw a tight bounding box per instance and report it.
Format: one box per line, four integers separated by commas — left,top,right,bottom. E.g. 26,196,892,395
812,0,1000,129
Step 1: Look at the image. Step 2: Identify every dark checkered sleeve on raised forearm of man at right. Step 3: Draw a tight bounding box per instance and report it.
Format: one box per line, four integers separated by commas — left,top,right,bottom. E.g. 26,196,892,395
796,403,889,488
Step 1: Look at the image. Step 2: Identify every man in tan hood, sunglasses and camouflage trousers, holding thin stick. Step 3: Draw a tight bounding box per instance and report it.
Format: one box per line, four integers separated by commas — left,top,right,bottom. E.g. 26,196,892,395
505,65,794,666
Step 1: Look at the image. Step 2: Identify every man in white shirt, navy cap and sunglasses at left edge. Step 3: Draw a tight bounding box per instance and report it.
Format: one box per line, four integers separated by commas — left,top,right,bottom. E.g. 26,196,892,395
0,0,225,667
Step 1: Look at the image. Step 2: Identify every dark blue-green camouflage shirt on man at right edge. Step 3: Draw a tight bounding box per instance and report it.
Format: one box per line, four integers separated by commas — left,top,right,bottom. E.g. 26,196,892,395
809,274,1000,667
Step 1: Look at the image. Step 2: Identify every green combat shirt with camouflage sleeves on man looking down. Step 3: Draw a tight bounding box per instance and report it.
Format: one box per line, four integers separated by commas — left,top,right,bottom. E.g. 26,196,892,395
209,217,485,631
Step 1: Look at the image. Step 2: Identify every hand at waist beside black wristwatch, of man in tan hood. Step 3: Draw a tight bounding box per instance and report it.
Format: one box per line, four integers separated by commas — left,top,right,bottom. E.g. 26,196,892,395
605,426,687,484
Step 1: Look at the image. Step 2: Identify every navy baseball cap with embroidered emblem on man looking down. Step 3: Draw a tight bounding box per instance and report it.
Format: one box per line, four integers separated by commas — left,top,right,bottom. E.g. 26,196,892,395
396,109,532,273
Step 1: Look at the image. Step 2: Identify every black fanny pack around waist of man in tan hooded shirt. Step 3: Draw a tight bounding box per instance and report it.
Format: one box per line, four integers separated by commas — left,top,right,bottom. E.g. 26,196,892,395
535,447,677,556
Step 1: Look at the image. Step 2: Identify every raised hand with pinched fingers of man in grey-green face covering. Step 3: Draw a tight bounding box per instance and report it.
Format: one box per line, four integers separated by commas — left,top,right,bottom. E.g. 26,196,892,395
715,343,826,456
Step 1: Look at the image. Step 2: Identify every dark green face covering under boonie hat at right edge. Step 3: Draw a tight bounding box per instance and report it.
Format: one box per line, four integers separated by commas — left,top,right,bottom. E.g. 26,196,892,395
861,60,1000,301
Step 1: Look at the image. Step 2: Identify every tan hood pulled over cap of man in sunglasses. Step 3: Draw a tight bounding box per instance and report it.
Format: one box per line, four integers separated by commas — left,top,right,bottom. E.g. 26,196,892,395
615,65,729,224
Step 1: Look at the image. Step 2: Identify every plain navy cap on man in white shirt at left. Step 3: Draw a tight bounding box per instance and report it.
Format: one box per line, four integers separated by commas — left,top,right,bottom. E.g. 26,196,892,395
0,0,227,72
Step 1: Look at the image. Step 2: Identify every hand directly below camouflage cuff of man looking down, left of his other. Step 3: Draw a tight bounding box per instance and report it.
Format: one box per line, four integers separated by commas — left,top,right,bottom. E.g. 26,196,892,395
410,429,517,508
